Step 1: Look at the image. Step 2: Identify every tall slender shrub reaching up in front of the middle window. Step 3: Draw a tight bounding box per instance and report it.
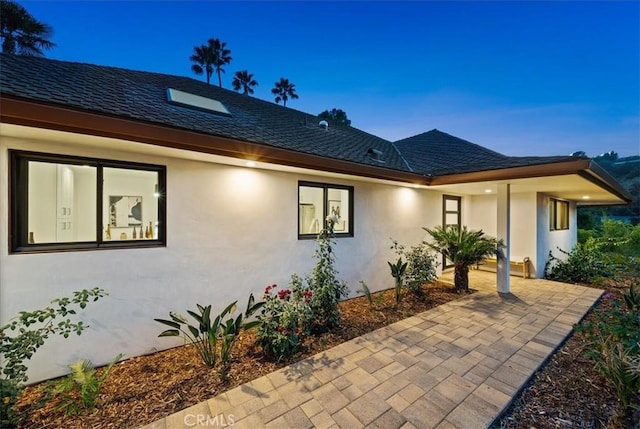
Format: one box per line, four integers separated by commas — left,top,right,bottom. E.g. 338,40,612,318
306,216,347,332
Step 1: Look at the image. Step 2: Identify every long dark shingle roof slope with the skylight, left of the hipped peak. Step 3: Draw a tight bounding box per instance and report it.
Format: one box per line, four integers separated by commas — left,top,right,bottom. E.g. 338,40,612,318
0,54,410,171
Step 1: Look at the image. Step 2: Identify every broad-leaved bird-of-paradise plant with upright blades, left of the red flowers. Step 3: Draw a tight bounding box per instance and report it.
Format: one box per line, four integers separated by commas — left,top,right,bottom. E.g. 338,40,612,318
153,294,264,367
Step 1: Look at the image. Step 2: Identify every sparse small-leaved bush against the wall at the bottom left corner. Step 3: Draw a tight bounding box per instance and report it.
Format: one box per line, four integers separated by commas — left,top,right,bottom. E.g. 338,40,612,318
0,288,107,427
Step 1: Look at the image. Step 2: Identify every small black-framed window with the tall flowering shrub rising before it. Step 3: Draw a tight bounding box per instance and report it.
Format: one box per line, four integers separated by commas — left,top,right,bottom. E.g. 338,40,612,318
298,182,353,238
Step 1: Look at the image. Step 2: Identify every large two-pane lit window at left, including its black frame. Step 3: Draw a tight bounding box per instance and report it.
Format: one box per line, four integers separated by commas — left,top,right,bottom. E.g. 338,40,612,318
10,151,166,252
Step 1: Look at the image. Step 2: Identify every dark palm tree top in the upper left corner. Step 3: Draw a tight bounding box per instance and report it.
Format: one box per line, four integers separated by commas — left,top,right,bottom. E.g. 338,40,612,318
0,0,56,57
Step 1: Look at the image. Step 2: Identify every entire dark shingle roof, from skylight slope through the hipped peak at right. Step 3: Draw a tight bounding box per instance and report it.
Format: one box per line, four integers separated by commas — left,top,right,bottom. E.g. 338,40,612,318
0,54,575,176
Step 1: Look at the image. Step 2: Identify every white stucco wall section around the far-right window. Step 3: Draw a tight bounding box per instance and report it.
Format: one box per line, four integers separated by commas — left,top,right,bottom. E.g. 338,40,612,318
536,193,578,277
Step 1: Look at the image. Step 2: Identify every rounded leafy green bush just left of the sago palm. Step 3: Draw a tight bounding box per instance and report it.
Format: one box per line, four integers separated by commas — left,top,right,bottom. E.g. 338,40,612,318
391,240,439,295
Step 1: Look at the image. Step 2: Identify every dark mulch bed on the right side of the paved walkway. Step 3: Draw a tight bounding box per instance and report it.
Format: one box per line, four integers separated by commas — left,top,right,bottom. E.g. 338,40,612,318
495,285,640,429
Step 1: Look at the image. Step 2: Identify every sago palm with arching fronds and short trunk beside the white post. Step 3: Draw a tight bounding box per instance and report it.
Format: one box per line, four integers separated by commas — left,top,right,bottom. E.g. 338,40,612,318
423,225,504,292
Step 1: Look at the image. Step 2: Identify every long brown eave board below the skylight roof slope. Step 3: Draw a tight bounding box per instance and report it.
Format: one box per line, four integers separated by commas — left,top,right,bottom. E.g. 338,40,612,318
0,94,428,185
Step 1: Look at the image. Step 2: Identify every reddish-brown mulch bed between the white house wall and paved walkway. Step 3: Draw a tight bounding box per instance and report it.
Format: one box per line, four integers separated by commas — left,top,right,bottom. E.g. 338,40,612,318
13,285,461,429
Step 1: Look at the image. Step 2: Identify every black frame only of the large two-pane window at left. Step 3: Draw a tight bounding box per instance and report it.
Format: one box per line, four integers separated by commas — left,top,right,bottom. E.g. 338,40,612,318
8,150,167,254
